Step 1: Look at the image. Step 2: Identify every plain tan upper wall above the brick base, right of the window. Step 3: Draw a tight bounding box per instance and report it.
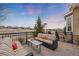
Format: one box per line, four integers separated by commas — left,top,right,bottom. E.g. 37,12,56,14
73,8,79,35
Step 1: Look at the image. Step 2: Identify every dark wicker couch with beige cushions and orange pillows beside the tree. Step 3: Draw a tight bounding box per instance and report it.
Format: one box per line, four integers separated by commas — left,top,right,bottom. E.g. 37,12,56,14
35,33,58,50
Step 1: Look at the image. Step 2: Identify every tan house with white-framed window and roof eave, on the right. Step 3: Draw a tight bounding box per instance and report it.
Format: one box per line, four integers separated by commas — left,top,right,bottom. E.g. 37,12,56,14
64,3,79,43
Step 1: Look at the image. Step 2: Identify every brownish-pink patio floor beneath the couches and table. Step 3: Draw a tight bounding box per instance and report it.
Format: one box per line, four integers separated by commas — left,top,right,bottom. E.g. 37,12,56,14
24,41,79,56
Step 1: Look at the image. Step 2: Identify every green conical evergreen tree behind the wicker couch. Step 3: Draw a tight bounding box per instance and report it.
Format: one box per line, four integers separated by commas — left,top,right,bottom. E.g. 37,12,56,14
33,16,45,36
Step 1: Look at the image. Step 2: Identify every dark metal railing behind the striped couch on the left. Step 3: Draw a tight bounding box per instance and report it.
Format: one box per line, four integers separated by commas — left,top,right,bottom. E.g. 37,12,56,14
0,32,33,44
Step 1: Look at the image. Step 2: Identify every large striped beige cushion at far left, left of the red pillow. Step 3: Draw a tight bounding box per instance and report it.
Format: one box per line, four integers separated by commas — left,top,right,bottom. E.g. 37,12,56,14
0,37,14,56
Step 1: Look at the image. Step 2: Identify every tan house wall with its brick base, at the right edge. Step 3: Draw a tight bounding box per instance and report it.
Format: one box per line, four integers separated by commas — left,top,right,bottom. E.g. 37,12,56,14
73,7,79,44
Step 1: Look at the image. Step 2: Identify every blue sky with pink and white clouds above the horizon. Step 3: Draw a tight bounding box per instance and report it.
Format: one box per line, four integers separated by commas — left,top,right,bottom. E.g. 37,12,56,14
0,3,68,29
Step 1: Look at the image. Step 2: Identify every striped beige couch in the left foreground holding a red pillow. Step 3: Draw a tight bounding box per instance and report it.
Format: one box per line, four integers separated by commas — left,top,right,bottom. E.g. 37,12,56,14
0,37,33,56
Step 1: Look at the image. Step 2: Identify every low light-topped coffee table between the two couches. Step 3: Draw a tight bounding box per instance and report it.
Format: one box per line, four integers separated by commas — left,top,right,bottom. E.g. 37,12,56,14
28,39,42,53
